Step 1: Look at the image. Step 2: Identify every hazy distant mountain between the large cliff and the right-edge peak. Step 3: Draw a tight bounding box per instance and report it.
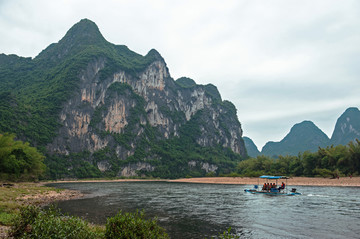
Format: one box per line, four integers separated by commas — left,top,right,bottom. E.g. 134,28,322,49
261,121,329,156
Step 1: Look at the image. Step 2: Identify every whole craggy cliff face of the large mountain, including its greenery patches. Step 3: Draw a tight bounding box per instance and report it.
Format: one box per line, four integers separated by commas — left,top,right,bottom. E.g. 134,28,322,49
41,19,246,176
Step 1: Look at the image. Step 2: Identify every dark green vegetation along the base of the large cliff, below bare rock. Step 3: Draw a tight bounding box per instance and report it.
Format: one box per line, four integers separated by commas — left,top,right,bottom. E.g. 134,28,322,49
45,107,243,178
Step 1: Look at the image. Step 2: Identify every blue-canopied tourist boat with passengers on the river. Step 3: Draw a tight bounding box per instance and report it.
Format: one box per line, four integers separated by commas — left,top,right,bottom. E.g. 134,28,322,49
244,175,301,196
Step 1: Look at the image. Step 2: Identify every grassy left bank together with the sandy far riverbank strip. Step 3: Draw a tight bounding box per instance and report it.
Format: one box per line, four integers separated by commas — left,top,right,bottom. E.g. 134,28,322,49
0,177,360,238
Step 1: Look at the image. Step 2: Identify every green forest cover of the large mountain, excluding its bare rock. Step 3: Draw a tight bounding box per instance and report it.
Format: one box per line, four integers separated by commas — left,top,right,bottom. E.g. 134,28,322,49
0,19,242,178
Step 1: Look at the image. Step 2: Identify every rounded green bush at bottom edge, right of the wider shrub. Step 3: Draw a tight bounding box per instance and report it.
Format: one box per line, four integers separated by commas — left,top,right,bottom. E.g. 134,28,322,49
105,210,169,239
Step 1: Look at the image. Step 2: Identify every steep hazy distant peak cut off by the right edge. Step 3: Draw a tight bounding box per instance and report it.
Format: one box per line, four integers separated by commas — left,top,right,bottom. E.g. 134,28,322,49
330,107,360,145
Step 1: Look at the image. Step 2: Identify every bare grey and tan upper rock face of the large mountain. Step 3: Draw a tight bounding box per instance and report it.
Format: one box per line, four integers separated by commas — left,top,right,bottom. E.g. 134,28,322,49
48,56,243,154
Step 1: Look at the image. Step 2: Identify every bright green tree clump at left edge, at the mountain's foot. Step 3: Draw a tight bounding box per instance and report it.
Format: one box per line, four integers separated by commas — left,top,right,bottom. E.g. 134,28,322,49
0,133,45,181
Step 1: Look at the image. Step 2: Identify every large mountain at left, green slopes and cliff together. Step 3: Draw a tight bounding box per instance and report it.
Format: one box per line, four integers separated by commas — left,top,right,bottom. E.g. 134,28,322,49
0,19,246,178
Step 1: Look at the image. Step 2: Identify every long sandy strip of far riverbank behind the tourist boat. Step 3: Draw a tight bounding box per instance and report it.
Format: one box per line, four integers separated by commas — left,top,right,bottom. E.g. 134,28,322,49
48,177,360,187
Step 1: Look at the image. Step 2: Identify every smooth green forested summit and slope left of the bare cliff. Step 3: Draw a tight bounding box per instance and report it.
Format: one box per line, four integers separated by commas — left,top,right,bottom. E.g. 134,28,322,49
0,19,158,146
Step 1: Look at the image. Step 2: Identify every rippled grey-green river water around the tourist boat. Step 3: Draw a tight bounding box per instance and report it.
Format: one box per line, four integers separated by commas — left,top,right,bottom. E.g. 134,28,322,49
51,182,360,238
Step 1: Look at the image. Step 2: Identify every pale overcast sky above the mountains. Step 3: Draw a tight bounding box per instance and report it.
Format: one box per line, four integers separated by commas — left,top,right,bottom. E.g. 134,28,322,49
0,0,360,150
